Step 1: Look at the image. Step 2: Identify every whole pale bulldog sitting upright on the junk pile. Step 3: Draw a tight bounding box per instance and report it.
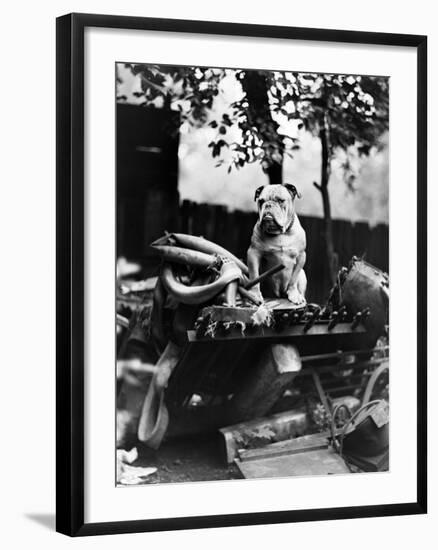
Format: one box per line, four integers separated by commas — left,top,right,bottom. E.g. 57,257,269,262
247,183,307,306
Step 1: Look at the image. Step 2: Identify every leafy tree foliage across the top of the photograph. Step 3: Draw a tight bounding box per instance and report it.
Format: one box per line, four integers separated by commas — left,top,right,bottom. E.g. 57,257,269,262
120,64,388,180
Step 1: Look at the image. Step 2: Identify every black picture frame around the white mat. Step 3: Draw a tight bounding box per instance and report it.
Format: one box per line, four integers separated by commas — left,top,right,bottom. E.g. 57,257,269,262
56,13,427,536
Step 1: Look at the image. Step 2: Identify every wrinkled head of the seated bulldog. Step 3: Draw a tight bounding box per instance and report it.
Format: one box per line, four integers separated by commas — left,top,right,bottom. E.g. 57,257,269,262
254,183,301,235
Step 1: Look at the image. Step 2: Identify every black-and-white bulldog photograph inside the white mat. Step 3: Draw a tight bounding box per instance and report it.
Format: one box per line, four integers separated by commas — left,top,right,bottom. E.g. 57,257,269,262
115,60,391,487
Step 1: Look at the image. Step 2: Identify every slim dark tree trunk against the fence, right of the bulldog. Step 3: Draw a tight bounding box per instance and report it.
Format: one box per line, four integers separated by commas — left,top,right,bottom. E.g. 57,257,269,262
314,117,338,285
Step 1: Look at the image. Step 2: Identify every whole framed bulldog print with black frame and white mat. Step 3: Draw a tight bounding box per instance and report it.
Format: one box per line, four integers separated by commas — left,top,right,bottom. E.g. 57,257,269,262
57,14,427,536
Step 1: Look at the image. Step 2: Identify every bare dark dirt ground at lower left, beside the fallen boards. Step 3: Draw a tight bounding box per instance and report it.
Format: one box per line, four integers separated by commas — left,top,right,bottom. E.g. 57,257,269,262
134,434,242,484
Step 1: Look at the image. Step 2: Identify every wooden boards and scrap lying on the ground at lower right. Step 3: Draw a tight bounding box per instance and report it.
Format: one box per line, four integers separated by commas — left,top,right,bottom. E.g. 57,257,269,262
220,363,389,479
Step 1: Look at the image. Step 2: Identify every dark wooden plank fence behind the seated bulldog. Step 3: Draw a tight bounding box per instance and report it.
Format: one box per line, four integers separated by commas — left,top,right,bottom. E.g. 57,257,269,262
121,198,389,302
